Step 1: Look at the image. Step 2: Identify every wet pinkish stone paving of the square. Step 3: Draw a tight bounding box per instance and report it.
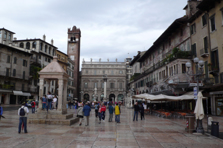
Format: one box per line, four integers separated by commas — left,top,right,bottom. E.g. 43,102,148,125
0,107,223,148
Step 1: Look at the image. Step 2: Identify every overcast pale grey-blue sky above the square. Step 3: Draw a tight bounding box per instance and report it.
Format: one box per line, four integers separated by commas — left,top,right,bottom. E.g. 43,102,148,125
0,0,187,65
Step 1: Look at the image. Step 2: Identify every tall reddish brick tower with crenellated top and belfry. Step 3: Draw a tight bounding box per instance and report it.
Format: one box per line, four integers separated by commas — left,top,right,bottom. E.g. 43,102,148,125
67,26,81,98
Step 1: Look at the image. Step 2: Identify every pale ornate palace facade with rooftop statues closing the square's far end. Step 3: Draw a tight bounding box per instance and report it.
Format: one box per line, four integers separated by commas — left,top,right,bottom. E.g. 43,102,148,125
81,59,127,101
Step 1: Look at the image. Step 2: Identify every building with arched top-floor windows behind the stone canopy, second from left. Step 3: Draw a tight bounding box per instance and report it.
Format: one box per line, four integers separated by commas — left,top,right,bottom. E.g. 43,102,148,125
13,35,57,99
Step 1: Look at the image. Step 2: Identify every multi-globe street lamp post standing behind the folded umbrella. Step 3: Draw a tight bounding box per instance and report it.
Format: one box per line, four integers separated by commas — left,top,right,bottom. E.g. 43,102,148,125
186,57,204,133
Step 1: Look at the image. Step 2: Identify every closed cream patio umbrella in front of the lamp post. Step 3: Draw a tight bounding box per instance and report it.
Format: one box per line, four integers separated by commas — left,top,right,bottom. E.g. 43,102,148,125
194,92,204,120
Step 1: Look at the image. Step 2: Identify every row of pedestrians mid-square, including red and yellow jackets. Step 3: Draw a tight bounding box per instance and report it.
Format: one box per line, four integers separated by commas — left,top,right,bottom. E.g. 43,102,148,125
77,102,121,126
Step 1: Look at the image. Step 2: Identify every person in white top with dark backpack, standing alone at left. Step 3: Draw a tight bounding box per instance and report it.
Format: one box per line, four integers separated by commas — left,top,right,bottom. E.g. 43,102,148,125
18,103,29,134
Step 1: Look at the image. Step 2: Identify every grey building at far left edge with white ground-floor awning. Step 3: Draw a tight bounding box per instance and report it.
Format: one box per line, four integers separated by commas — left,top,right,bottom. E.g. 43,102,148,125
0,28,32,104
